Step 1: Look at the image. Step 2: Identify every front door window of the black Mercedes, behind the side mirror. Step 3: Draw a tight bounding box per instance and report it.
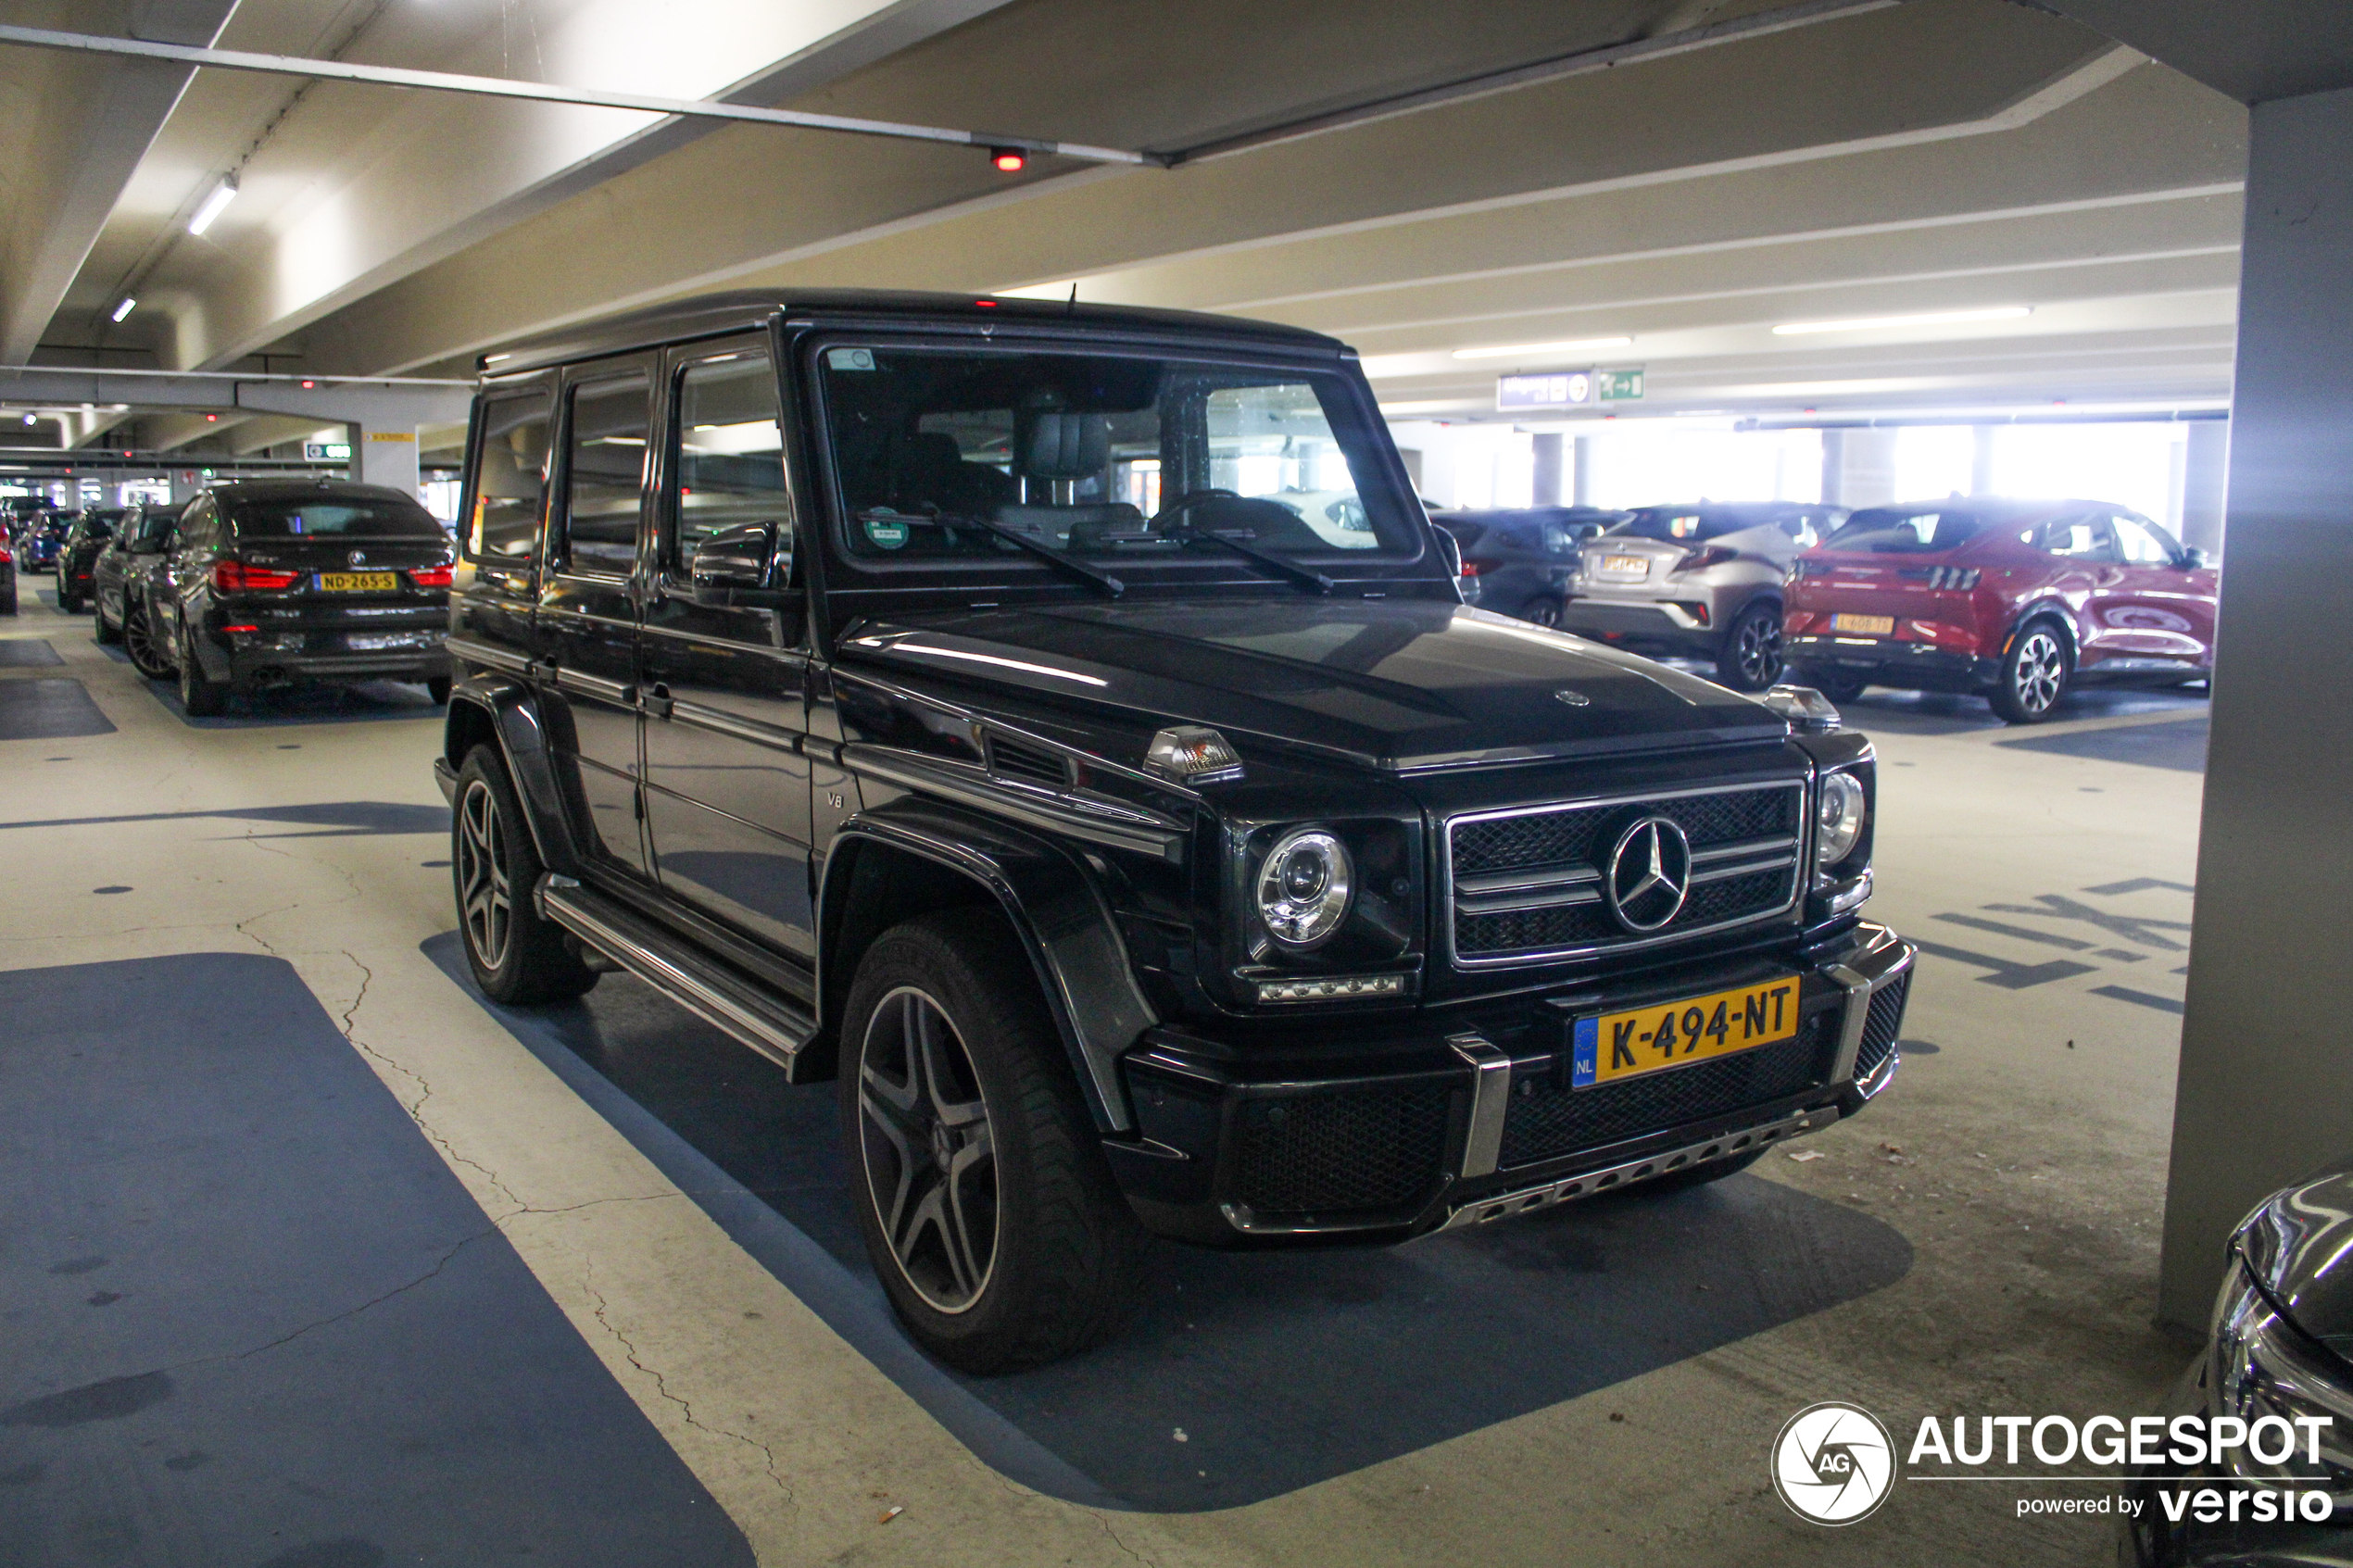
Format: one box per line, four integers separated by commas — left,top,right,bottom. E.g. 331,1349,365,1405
661,350,793,581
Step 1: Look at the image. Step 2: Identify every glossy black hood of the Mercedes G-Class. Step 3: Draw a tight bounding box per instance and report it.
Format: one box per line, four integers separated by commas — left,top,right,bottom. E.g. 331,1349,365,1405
837,599,1788,771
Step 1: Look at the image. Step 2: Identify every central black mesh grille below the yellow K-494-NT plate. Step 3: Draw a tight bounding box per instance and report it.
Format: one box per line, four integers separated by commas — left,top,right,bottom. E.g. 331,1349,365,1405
1504,1006,1843,1166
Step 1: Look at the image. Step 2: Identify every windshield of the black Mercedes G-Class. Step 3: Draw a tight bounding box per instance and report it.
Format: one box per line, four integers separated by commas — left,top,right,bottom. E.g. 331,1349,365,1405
819,345,1421,571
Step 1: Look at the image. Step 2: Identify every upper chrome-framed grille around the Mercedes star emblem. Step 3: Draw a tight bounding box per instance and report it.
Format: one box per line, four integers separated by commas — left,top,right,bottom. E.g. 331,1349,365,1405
1447,783,1805,964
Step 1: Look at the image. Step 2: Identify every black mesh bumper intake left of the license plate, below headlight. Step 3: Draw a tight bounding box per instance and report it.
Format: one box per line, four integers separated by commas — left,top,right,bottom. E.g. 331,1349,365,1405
1233,1084,1452,1218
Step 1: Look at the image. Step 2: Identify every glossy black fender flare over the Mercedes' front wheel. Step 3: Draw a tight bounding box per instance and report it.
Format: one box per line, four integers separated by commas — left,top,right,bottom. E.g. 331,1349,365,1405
816,797,1160,1133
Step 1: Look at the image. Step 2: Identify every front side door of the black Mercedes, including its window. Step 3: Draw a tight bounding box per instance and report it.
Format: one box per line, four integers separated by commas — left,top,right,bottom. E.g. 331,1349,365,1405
640,339,816,960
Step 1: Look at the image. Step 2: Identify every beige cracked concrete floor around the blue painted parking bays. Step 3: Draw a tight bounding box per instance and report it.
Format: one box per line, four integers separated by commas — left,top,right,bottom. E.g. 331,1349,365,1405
0,585,2200,1568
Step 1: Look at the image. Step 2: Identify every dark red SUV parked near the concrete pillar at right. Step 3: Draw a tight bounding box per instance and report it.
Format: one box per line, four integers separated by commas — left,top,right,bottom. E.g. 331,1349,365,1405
1788,498,2219,724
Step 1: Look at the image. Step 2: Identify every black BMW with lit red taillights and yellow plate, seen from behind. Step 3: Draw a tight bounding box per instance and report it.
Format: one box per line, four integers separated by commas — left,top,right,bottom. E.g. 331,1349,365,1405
132,480,452,715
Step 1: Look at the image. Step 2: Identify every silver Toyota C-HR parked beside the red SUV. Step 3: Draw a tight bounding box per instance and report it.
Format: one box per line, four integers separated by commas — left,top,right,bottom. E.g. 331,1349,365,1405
1560,501,1847,691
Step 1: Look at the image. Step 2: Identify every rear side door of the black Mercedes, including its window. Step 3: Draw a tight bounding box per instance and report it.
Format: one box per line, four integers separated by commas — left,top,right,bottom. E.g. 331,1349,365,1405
535,359,652,877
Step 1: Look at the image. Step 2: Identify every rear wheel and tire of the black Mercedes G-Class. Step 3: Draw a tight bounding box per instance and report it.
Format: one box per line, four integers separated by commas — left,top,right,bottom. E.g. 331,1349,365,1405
449,746,598,1006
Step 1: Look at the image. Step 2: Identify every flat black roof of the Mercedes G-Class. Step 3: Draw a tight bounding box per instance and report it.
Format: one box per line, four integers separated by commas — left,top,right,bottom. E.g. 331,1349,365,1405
475,289,1348,376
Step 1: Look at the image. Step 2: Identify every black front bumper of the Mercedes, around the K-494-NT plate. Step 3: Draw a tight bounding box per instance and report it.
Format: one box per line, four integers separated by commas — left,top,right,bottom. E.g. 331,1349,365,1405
1103,924,1916,1246
